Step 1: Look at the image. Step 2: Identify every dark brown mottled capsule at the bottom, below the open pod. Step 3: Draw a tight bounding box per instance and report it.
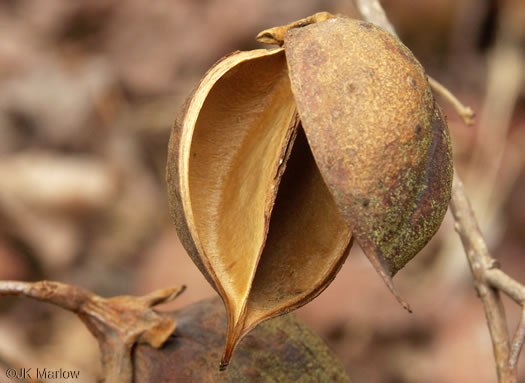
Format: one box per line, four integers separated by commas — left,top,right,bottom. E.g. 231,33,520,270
133,298,350,383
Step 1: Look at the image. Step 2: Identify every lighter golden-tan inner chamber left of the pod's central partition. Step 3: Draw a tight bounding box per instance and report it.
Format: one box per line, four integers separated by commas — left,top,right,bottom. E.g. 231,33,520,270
189,53,295,320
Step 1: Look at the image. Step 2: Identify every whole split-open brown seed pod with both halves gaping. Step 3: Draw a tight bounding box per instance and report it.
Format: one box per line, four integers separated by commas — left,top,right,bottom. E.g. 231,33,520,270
167,13,452,366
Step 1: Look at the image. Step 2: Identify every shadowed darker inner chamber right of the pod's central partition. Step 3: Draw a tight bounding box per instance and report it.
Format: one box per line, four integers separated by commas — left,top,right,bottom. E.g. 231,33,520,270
244,128,351,328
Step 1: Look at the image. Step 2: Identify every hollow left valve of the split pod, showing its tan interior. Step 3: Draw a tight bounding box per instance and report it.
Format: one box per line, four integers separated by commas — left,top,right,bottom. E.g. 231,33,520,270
167,49,351,365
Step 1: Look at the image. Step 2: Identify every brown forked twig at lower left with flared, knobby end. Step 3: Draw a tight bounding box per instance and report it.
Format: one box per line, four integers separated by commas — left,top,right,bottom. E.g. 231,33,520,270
0,281,185,383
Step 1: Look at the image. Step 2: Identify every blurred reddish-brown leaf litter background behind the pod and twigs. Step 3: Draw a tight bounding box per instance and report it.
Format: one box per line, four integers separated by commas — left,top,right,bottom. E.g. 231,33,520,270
0,0,525,383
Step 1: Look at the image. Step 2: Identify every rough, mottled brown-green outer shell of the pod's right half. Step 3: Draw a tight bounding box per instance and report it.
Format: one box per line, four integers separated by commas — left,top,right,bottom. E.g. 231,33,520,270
284,17,452,306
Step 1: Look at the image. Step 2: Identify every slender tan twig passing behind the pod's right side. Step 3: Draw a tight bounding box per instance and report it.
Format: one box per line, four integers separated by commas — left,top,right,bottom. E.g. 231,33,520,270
356,0,525,383
